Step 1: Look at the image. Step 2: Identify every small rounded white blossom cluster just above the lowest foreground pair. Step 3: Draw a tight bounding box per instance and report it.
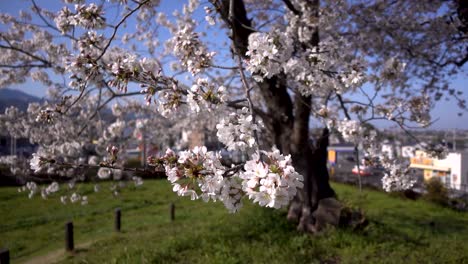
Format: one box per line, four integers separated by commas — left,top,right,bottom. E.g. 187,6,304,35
216,107,260,151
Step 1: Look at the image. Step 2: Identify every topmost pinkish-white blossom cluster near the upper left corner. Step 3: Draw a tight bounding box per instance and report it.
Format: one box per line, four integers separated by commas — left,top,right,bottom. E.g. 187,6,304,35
54,3,106,34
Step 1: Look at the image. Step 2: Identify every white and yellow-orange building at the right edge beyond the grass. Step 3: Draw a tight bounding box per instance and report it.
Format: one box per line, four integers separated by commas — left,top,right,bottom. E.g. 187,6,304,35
410,150,468,192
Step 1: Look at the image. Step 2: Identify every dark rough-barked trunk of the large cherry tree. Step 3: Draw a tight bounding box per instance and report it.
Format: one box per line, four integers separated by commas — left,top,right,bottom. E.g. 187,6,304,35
212,0,335,232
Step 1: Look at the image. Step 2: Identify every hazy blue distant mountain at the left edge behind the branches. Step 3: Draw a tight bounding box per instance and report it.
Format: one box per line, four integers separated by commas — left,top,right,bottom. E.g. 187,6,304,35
0,88,42,114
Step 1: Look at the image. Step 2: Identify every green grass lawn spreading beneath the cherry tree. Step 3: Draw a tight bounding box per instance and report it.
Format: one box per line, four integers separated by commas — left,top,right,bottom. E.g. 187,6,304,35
0,180,468,263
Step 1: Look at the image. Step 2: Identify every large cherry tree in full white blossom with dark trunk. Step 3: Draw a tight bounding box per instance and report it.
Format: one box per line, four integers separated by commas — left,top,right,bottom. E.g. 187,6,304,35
0,0,468,231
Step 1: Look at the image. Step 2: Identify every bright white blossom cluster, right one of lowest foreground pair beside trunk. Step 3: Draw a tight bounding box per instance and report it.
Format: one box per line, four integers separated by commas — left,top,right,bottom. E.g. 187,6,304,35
239,149,303,209
